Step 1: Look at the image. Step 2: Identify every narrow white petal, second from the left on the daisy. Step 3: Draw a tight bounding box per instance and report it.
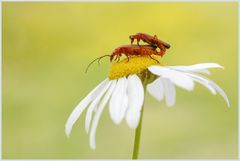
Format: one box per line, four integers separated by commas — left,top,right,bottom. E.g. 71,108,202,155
85,81,112,133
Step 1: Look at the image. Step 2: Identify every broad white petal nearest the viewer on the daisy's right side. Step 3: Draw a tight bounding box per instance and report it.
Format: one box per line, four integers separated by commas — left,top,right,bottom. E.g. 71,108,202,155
148,66,194,91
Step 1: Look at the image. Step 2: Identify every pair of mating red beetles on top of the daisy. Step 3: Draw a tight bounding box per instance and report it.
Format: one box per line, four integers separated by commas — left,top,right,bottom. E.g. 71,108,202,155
86,33,170,72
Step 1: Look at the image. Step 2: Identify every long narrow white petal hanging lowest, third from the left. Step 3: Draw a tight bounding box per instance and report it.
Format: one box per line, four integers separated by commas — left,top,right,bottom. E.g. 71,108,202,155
90,80,116,149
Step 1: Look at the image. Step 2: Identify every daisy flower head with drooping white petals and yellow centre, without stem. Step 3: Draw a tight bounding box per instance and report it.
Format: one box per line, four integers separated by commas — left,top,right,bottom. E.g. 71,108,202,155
65,56,230,149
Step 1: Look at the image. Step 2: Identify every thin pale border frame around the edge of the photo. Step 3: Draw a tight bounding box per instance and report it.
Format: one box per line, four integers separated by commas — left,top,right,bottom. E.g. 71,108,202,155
0,0,240,161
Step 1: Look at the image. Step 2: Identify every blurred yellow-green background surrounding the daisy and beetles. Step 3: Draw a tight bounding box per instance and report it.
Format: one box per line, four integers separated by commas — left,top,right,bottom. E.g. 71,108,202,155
2,2,238,159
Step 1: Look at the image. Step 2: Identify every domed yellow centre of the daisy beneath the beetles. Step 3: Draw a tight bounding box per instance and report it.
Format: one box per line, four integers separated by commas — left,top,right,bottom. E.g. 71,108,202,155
108,56,160,80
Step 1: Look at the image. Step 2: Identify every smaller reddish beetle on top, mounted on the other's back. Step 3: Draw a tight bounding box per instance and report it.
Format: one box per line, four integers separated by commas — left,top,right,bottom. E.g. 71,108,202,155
129,33,170,55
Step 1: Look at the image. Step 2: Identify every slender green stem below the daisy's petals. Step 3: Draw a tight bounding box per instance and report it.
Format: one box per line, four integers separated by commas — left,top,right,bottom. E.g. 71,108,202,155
132,102,144,159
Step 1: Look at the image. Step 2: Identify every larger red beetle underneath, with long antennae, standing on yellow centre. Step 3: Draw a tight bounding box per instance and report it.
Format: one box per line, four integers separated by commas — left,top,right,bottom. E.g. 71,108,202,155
85,45,160,72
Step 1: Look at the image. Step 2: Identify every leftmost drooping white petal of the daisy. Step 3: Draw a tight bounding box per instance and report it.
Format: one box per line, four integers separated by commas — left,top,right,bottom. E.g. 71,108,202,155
65,79,109,137
